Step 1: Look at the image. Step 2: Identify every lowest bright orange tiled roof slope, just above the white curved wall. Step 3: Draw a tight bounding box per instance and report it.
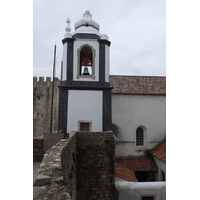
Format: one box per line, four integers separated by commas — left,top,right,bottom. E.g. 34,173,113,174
115,162,138,182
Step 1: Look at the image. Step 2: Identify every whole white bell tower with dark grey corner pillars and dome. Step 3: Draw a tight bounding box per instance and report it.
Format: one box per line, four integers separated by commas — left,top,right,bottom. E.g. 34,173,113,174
59,11,112,133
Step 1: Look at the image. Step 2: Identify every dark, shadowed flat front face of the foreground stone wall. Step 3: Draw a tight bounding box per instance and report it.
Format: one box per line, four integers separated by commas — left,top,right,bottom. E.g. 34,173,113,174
76,131,118,200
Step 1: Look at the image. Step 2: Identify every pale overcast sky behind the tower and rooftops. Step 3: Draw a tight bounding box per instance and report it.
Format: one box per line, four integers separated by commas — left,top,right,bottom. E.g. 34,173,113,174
33,0,166,78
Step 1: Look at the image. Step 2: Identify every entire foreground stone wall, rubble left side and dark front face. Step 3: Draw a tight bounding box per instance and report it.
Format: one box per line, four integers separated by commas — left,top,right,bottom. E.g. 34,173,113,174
33,131,118,200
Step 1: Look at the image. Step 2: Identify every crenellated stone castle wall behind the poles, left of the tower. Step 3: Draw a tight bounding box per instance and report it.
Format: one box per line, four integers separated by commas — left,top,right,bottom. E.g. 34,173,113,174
33,77,60,138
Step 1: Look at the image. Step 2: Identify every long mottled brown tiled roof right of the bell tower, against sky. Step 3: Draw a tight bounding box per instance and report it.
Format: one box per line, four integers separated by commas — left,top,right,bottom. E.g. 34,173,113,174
110,75,166,95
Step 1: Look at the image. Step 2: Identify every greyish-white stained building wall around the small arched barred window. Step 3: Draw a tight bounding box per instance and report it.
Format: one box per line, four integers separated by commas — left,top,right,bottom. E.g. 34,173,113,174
112,94,166,156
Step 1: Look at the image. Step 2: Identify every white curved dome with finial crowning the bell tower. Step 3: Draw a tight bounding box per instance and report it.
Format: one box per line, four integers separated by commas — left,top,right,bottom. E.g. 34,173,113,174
74,10,100,31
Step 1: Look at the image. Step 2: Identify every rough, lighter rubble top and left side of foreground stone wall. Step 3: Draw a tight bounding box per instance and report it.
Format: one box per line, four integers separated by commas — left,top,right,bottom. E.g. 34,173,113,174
33,133,76,200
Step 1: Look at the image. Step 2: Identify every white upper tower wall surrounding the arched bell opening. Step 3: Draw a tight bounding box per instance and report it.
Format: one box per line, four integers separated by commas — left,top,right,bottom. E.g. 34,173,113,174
73,39,99,81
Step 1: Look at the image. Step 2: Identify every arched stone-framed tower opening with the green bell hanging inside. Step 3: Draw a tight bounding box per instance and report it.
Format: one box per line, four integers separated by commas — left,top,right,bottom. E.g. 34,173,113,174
77,44,95,79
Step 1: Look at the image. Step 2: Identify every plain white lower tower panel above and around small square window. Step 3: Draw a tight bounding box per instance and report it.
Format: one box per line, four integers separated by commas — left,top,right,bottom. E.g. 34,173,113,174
67,90,103,133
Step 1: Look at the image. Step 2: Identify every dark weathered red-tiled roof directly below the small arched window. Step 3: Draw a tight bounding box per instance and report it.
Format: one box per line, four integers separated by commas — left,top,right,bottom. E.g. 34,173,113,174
116,156,158,172
